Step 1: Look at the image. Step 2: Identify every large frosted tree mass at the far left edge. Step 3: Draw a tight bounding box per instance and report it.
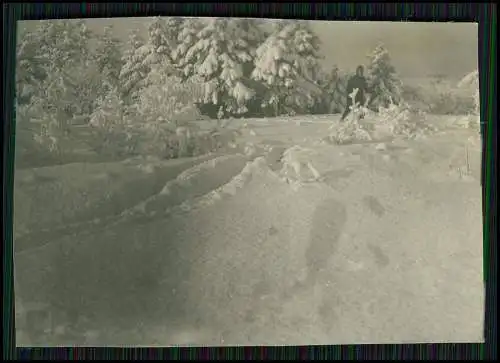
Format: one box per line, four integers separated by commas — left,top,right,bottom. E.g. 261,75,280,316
18,20,100,150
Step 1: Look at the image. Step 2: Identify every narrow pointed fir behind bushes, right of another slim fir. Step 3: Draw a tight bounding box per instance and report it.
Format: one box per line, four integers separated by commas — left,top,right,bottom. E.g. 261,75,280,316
119,29,150,104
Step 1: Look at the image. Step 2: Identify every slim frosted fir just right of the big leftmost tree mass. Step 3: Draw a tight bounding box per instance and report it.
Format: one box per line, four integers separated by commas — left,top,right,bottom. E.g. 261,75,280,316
93,26,122,90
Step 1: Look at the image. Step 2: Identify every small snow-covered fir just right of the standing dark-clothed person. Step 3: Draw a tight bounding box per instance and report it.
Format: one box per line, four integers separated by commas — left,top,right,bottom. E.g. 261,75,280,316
367,44,402,108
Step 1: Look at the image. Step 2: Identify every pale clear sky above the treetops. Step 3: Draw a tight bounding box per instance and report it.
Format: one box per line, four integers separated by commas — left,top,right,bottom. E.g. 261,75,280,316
23,18,478,79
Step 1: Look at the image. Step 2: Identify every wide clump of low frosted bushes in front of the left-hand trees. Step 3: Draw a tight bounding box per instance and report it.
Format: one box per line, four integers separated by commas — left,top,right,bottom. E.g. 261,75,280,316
90,77,244,159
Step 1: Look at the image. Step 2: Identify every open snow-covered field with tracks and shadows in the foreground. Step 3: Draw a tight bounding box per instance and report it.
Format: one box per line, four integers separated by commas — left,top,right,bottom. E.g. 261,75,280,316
14,116,484,346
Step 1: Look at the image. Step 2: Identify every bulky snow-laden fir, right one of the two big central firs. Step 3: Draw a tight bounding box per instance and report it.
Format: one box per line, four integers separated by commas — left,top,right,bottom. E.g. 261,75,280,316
252,21,322,115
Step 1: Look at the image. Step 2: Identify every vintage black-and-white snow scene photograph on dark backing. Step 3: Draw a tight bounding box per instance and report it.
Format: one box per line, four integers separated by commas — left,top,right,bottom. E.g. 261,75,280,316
14,17,484,347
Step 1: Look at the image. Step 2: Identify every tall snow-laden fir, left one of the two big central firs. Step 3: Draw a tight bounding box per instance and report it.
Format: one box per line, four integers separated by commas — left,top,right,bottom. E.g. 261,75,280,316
177,18,254,114
